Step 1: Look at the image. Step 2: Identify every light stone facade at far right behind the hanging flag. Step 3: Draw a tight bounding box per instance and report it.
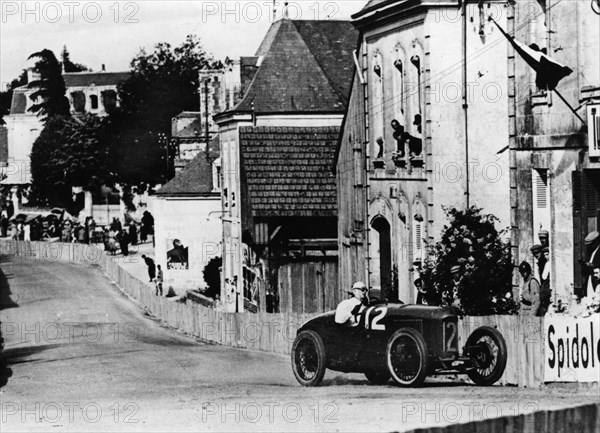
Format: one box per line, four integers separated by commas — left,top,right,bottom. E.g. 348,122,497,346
507,0,600,300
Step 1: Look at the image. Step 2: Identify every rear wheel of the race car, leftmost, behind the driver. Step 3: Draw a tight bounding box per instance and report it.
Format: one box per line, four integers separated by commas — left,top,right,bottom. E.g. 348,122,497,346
292,330,327,386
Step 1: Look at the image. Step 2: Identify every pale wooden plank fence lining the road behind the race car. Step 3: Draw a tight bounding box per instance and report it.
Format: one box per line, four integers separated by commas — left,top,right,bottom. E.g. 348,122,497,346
0,241,544,387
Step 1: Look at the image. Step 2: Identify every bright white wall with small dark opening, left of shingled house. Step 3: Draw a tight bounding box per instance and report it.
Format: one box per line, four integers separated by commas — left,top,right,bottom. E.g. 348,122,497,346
150,197,222,294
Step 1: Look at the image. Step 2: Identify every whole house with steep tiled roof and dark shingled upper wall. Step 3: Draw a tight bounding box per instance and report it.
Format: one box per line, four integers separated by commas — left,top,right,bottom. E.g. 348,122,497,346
215,18,358,312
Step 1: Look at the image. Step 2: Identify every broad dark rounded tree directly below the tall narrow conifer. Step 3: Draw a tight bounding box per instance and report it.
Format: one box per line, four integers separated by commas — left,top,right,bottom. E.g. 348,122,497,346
30,114,112,209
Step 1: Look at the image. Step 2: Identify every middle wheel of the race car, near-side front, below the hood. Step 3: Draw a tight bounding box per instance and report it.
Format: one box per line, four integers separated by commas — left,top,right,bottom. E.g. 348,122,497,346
385,328,429,387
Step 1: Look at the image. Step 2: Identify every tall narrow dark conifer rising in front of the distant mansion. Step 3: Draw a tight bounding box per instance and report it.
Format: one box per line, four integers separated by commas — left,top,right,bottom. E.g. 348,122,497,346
27,49,70,117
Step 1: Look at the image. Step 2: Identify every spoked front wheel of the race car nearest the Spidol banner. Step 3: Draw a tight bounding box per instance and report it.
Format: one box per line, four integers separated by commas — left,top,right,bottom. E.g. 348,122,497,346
466,326,507,386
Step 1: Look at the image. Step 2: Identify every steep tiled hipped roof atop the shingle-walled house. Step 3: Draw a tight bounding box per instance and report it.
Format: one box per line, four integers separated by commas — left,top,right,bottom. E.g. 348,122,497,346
233,19,358,113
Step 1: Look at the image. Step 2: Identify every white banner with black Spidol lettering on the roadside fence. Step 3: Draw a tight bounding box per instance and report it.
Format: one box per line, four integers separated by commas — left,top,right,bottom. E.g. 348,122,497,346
544,314,600,382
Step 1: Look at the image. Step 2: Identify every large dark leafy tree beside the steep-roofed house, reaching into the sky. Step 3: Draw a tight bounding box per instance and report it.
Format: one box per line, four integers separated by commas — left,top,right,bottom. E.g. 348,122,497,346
110,35,222,184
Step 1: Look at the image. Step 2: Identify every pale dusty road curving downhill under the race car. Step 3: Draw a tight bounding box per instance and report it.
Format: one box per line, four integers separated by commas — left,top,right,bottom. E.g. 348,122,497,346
0,258,597,432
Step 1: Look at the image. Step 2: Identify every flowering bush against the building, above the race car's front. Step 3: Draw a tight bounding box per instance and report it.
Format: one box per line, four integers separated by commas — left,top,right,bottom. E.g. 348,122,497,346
421,207,517,316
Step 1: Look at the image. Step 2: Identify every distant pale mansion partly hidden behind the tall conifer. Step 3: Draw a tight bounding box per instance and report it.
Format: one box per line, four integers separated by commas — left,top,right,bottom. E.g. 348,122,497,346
2,70,129,186
